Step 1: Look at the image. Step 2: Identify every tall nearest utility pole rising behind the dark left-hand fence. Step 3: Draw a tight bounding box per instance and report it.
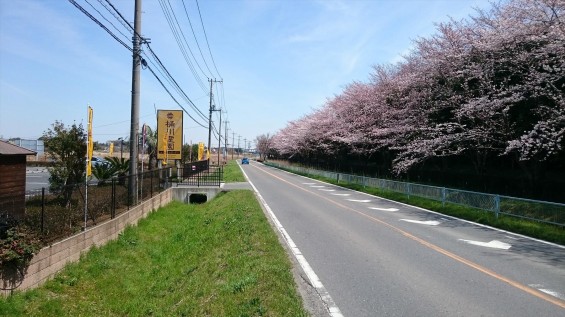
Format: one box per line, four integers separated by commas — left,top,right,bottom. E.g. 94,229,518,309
128,0,142,205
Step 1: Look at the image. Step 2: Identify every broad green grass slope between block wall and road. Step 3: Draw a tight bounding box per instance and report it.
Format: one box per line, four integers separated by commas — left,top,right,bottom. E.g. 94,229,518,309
0,190,307,316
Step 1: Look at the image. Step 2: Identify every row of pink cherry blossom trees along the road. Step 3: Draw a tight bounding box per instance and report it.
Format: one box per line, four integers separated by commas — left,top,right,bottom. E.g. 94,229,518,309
273,0,565,185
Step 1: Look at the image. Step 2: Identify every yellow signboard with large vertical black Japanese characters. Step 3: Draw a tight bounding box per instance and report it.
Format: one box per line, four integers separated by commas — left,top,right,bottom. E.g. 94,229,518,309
157,110,182,161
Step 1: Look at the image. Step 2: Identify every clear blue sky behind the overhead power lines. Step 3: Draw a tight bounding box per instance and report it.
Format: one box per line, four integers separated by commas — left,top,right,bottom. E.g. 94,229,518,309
0,0,491,143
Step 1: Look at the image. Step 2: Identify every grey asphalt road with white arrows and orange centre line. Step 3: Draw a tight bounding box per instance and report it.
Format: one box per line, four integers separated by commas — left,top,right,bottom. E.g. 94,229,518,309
242,162,565,317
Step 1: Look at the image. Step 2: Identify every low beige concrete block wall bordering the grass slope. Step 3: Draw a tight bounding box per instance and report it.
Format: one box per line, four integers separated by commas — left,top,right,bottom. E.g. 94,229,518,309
0,188,173,295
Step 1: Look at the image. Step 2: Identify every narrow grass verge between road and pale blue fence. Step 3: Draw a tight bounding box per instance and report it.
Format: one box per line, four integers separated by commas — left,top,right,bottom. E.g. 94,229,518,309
276,169,565,245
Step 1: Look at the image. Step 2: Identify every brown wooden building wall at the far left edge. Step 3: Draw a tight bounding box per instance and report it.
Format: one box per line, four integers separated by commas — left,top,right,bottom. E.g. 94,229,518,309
0,155,26,218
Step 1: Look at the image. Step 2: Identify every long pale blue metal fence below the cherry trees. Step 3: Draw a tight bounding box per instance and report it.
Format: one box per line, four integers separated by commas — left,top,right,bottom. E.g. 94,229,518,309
265,162,565,227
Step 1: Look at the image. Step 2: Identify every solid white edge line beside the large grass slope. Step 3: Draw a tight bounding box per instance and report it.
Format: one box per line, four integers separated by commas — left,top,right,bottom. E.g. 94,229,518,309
240,166,343,317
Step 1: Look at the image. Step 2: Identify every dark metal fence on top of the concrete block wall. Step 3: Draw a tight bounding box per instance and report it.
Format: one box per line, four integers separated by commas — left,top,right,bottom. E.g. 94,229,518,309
0,168,171,244
